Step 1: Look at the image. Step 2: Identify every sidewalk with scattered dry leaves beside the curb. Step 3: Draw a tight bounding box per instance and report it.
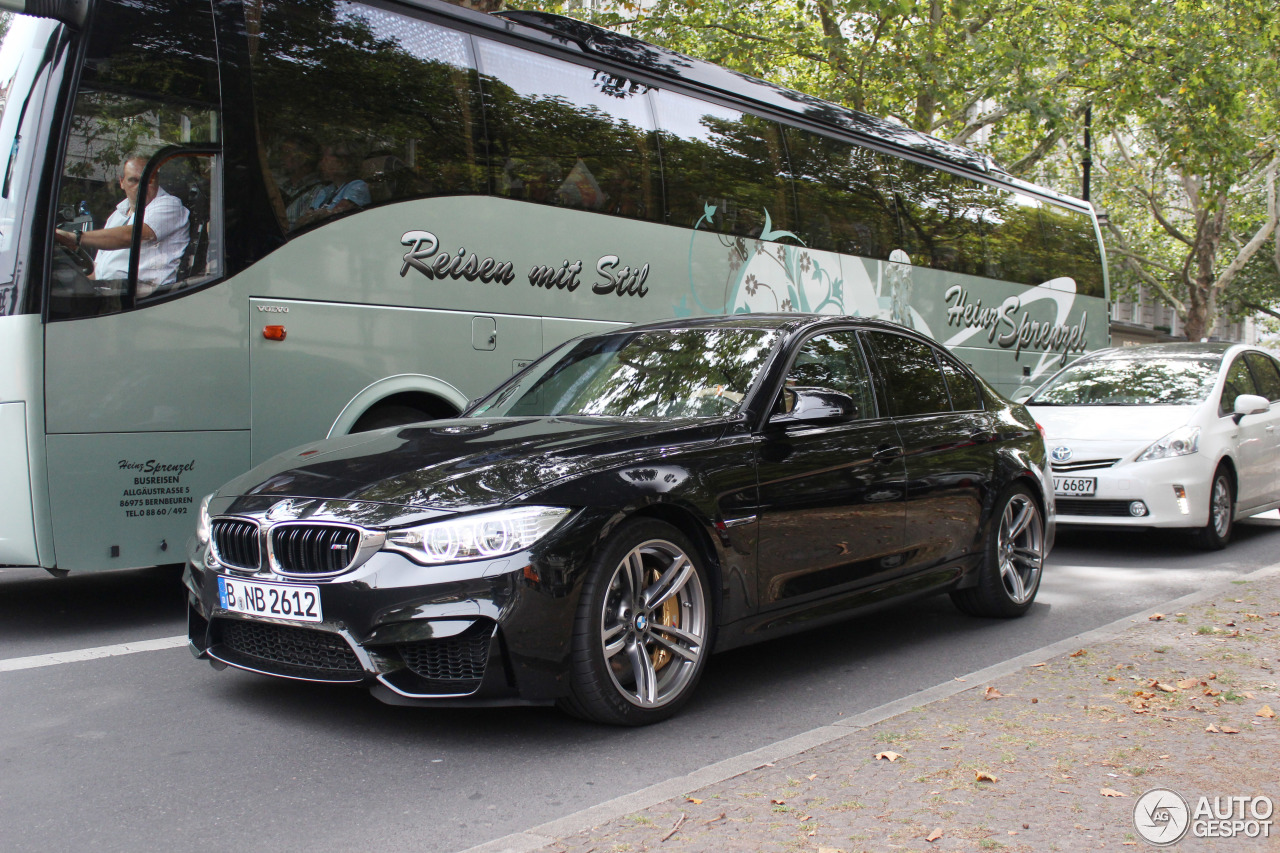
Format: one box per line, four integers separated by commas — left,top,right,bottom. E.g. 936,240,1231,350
476,565,1280,853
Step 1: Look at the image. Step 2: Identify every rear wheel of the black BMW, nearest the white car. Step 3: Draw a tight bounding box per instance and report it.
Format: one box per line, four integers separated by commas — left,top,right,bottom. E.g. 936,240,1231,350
951,485,1044,617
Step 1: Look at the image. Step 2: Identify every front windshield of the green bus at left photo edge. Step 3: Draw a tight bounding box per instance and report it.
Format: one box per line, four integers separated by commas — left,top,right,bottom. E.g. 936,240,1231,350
0,15,58,316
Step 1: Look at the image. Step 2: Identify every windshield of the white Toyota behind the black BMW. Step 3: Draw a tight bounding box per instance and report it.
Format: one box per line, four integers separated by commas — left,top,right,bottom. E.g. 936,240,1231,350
1027,359,1222,406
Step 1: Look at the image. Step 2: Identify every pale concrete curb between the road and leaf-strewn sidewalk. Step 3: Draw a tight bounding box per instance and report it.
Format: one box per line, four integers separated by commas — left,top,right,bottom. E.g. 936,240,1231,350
462,562,1280,853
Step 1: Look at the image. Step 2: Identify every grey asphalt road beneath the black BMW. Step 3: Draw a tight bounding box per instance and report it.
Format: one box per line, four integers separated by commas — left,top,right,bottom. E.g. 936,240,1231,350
0,512,1280,853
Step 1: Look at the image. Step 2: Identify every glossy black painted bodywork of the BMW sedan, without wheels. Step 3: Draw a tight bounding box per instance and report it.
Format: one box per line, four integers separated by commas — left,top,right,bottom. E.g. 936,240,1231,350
184,315,1052,704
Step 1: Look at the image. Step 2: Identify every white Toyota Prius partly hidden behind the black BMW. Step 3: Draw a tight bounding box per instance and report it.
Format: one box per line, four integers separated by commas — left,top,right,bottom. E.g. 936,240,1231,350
1025,343,1280,548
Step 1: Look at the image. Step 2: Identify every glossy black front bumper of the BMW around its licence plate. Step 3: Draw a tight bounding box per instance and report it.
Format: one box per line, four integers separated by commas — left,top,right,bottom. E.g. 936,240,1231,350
183,517,599,706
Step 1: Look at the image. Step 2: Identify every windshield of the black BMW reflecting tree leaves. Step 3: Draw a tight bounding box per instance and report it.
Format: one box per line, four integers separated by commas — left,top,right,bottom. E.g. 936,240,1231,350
470,329,777,418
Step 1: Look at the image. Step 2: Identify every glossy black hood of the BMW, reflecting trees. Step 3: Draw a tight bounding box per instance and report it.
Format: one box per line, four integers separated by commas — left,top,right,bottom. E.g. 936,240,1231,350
219,418,727,511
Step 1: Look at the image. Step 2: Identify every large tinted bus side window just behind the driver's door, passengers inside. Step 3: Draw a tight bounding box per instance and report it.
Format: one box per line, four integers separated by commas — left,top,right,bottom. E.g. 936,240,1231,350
246,0,488,232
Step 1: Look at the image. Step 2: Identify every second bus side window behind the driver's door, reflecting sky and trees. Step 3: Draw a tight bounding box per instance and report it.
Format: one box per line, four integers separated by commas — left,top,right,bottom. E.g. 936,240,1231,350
476,40,662,219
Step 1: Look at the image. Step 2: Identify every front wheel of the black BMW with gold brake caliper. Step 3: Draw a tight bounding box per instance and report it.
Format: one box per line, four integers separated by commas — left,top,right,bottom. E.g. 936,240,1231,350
562,519,712,725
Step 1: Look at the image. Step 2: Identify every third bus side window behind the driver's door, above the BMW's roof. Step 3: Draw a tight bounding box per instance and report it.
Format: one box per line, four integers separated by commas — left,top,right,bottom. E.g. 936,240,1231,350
654,91,796,240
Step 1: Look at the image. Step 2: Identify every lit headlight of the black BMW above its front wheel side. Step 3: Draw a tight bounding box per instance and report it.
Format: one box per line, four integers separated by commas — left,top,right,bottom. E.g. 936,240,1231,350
383,506,570,566
